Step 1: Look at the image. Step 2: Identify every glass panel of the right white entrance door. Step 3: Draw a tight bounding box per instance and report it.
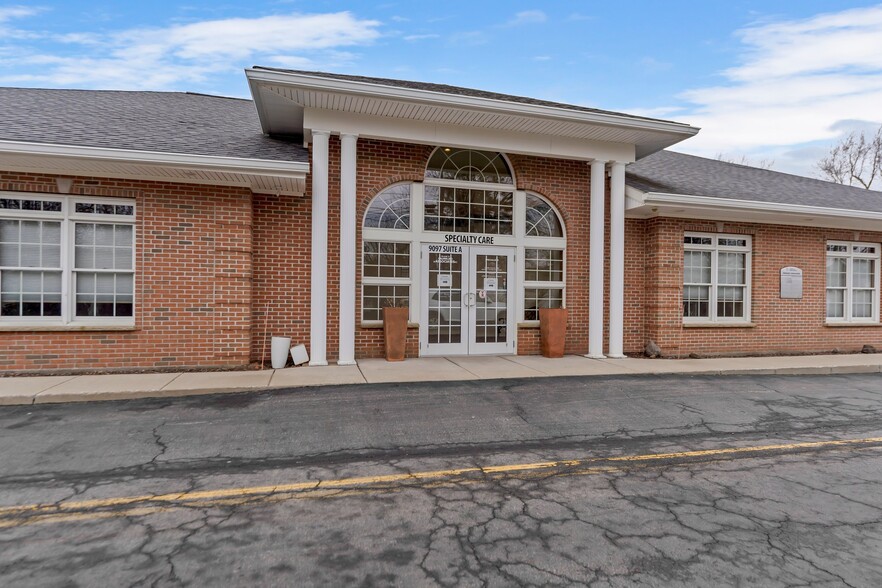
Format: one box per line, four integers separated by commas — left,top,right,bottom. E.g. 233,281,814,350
475,254,508,343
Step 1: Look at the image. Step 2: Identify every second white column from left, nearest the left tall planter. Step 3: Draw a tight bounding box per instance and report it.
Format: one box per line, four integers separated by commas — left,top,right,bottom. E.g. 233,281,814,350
337,134,358,365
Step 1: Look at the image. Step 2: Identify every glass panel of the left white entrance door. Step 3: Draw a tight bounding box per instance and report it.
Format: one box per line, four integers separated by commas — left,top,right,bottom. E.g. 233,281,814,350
428,253,463,344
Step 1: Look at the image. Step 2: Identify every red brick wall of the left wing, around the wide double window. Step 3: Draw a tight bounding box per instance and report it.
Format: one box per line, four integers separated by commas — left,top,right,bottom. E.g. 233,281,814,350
0,172,252,370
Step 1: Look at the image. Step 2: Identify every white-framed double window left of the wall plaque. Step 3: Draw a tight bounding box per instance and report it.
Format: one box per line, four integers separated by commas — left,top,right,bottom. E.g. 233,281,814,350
683,233,751,324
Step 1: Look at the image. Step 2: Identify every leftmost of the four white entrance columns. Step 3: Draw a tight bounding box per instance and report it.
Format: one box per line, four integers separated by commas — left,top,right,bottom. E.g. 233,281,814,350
309,131,330,365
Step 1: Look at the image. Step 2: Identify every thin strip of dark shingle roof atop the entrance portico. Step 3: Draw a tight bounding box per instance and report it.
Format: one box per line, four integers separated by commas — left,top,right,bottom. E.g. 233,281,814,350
252,66,679,124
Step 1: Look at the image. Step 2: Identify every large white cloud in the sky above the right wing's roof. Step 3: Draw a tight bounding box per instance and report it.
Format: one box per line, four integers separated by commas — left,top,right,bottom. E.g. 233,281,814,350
678,5,882,175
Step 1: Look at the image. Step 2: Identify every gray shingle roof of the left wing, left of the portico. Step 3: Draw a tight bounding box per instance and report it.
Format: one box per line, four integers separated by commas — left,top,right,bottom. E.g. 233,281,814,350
0,88,308,162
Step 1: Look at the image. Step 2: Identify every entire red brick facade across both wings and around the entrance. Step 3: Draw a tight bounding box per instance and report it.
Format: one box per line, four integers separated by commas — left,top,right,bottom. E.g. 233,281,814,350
0,156,882,370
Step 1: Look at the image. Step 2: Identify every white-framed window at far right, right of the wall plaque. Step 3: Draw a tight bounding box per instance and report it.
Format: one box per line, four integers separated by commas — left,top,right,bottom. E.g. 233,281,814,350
827,241,880,323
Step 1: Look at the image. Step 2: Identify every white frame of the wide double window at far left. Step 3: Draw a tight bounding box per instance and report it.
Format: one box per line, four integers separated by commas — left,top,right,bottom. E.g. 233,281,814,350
0,192,138,330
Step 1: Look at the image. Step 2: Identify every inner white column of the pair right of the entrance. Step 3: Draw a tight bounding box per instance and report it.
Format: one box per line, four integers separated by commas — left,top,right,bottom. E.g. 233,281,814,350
588,160,606,359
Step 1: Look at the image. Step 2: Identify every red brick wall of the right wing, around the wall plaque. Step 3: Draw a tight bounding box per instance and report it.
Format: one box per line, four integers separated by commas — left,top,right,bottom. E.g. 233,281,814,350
646,219,882,356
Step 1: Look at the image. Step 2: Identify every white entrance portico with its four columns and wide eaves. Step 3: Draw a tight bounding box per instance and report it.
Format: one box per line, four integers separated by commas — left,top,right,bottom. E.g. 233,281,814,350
246,68,698,365
